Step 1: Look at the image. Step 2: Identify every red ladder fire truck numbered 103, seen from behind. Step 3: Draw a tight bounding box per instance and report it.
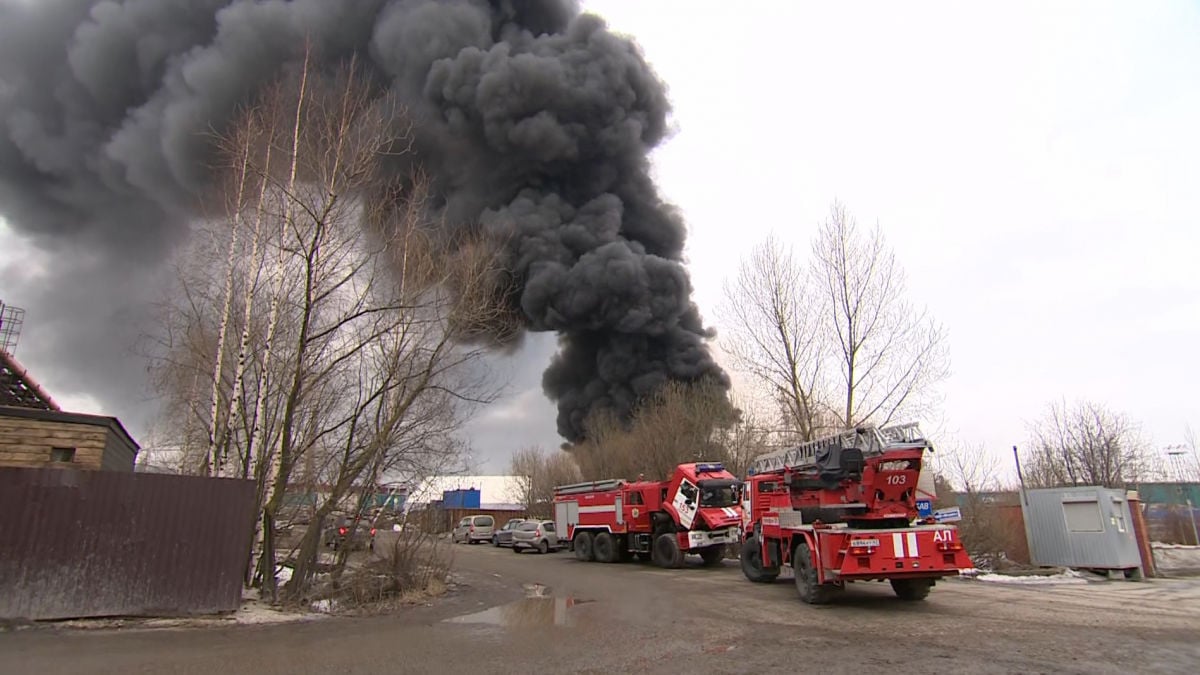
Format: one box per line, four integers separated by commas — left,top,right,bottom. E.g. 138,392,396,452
740,423,972,604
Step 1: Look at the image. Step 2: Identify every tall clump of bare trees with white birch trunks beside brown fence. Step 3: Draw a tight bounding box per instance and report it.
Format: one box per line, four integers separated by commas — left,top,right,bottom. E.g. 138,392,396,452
144,56,503,598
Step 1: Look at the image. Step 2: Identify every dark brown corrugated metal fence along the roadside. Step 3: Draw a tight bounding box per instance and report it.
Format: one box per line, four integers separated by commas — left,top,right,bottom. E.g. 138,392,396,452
0,468,254,620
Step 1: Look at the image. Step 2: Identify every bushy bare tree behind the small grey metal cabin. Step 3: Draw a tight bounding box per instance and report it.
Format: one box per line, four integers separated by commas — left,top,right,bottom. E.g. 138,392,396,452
1022,401,1151,488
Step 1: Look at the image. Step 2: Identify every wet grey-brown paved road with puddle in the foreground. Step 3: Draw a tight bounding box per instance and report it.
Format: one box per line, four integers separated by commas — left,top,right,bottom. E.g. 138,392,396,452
0,545,1200,675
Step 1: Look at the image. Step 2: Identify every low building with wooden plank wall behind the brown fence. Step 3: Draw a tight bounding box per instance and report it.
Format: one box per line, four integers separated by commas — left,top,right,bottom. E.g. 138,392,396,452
0,406,139,471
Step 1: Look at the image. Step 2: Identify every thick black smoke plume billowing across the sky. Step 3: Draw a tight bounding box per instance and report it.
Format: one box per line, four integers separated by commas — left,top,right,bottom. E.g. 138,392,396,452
0,0,726,441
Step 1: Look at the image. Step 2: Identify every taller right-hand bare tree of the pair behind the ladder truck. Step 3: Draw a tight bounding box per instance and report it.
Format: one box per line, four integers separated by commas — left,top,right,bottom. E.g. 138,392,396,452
812,203,949,426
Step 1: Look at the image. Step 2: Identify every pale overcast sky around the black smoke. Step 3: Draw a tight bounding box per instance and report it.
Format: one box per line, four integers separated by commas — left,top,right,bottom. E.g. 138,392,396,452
0,0,1200,472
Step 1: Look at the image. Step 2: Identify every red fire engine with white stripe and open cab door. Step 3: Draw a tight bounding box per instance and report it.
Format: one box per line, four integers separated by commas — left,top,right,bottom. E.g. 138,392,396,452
554,462,742,567
